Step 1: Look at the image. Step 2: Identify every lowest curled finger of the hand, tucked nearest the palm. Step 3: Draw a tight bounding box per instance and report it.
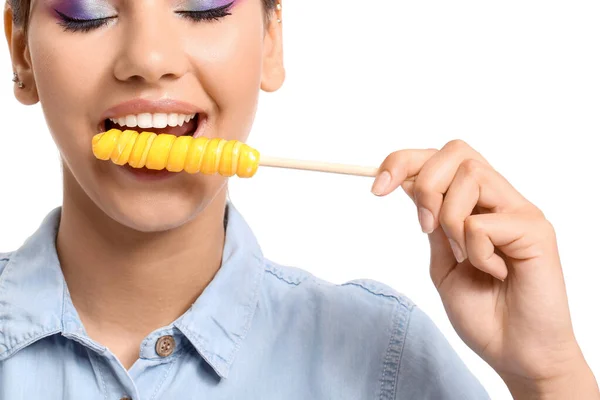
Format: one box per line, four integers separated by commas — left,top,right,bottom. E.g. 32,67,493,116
465,213,554,281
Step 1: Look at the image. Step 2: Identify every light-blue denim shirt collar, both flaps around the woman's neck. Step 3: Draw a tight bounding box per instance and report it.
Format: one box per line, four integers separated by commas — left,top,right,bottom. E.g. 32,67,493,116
0,203,264,378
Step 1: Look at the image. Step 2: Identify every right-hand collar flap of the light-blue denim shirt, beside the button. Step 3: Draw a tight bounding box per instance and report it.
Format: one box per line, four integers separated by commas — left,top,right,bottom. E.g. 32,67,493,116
174,204,265,378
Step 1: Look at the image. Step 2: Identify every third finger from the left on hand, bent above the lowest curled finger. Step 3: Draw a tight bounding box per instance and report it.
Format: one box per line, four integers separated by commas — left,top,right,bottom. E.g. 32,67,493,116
439,159,535,263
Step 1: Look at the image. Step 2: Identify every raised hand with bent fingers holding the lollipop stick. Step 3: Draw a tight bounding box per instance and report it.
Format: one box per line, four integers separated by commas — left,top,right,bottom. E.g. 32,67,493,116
373,141,600,399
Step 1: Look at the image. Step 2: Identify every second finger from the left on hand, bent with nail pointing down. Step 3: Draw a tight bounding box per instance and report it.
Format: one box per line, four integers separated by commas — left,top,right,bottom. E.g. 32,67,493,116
413,140,487,233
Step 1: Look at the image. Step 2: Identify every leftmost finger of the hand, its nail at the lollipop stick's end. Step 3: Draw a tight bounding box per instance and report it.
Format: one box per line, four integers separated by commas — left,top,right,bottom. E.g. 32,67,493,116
371,149,438,196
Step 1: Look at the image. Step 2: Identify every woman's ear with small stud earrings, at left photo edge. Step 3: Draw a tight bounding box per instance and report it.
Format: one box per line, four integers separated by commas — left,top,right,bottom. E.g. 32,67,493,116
4,2,39,105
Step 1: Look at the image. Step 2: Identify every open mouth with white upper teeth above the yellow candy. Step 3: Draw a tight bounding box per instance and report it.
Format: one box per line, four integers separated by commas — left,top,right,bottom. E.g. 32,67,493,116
103,113,207,137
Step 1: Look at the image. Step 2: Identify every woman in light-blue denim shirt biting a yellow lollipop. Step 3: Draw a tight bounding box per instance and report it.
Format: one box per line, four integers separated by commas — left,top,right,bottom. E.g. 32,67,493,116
0,0,599,399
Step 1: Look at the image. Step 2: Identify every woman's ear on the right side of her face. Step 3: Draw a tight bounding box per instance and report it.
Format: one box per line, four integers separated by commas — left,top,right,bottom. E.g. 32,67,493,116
260,4,285,92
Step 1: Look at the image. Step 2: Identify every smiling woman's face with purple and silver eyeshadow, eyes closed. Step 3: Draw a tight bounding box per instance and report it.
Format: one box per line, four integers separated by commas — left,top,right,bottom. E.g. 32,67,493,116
6,0,283,231
